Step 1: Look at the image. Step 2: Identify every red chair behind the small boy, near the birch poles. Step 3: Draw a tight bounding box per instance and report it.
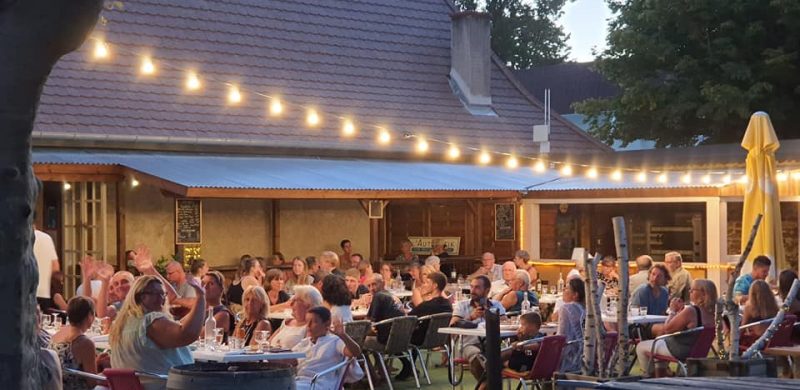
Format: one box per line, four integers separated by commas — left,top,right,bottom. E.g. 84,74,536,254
502,336,564,390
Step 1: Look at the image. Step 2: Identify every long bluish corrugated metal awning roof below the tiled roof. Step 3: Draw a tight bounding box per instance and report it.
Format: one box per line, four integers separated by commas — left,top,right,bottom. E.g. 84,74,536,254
33,150,558,191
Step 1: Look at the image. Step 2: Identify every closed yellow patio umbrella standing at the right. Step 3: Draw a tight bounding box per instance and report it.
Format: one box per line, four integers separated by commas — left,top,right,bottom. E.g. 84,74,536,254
742,111,786,279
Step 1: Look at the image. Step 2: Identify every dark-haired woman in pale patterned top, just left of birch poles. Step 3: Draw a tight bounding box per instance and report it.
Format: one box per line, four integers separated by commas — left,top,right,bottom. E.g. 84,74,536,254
556,278,586,372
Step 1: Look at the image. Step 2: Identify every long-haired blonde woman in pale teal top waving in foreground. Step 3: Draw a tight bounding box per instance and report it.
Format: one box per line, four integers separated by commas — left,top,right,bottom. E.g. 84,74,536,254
109,275,206,389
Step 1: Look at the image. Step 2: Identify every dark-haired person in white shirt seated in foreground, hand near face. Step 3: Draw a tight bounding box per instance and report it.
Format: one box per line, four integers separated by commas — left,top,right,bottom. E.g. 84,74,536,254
292,306,361,390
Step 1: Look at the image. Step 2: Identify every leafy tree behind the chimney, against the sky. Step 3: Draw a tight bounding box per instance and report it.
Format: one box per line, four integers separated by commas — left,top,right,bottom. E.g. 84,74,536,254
456,0,569,69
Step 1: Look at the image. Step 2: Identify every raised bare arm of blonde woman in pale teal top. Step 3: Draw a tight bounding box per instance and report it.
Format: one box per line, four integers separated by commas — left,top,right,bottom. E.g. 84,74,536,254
147,279,206,349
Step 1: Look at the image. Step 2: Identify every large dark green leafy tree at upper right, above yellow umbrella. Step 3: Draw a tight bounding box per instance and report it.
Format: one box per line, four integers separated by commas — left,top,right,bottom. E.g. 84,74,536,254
576,0,800,147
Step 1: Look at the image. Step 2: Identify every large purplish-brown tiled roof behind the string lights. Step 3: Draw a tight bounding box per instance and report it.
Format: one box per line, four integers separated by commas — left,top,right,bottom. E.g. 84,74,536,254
29,0,608,154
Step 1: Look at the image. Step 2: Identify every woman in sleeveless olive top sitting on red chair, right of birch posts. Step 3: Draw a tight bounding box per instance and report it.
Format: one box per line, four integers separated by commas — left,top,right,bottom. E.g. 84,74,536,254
636,279,717,374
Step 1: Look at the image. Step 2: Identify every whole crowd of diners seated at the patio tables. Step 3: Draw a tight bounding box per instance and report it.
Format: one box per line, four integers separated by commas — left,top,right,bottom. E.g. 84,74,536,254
31,225,800,389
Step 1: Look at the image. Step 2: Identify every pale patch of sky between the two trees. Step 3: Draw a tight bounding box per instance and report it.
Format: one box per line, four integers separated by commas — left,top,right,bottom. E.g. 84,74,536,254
560,0,611,62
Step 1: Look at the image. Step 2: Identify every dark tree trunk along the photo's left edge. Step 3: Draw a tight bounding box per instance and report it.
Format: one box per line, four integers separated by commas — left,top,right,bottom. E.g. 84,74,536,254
0,0,103,389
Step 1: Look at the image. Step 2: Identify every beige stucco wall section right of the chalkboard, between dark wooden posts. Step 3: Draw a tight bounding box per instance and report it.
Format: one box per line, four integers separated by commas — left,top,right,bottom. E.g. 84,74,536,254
279,200,370,258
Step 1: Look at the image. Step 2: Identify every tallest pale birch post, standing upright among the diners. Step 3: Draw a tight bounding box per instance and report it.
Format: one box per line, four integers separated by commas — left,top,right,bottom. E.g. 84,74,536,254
611,217,630,375
